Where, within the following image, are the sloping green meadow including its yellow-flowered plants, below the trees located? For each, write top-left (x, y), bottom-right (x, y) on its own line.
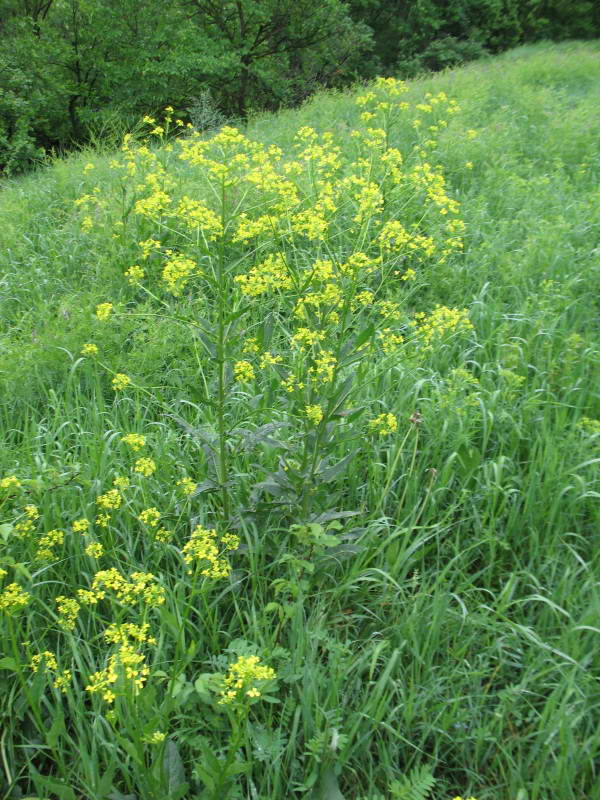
top-left (0, 42), bottom-right (600, 800)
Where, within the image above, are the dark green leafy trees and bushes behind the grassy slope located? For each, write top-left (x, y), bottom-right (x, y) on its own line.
top-left (0, 0), bottom-right (600, 173)
